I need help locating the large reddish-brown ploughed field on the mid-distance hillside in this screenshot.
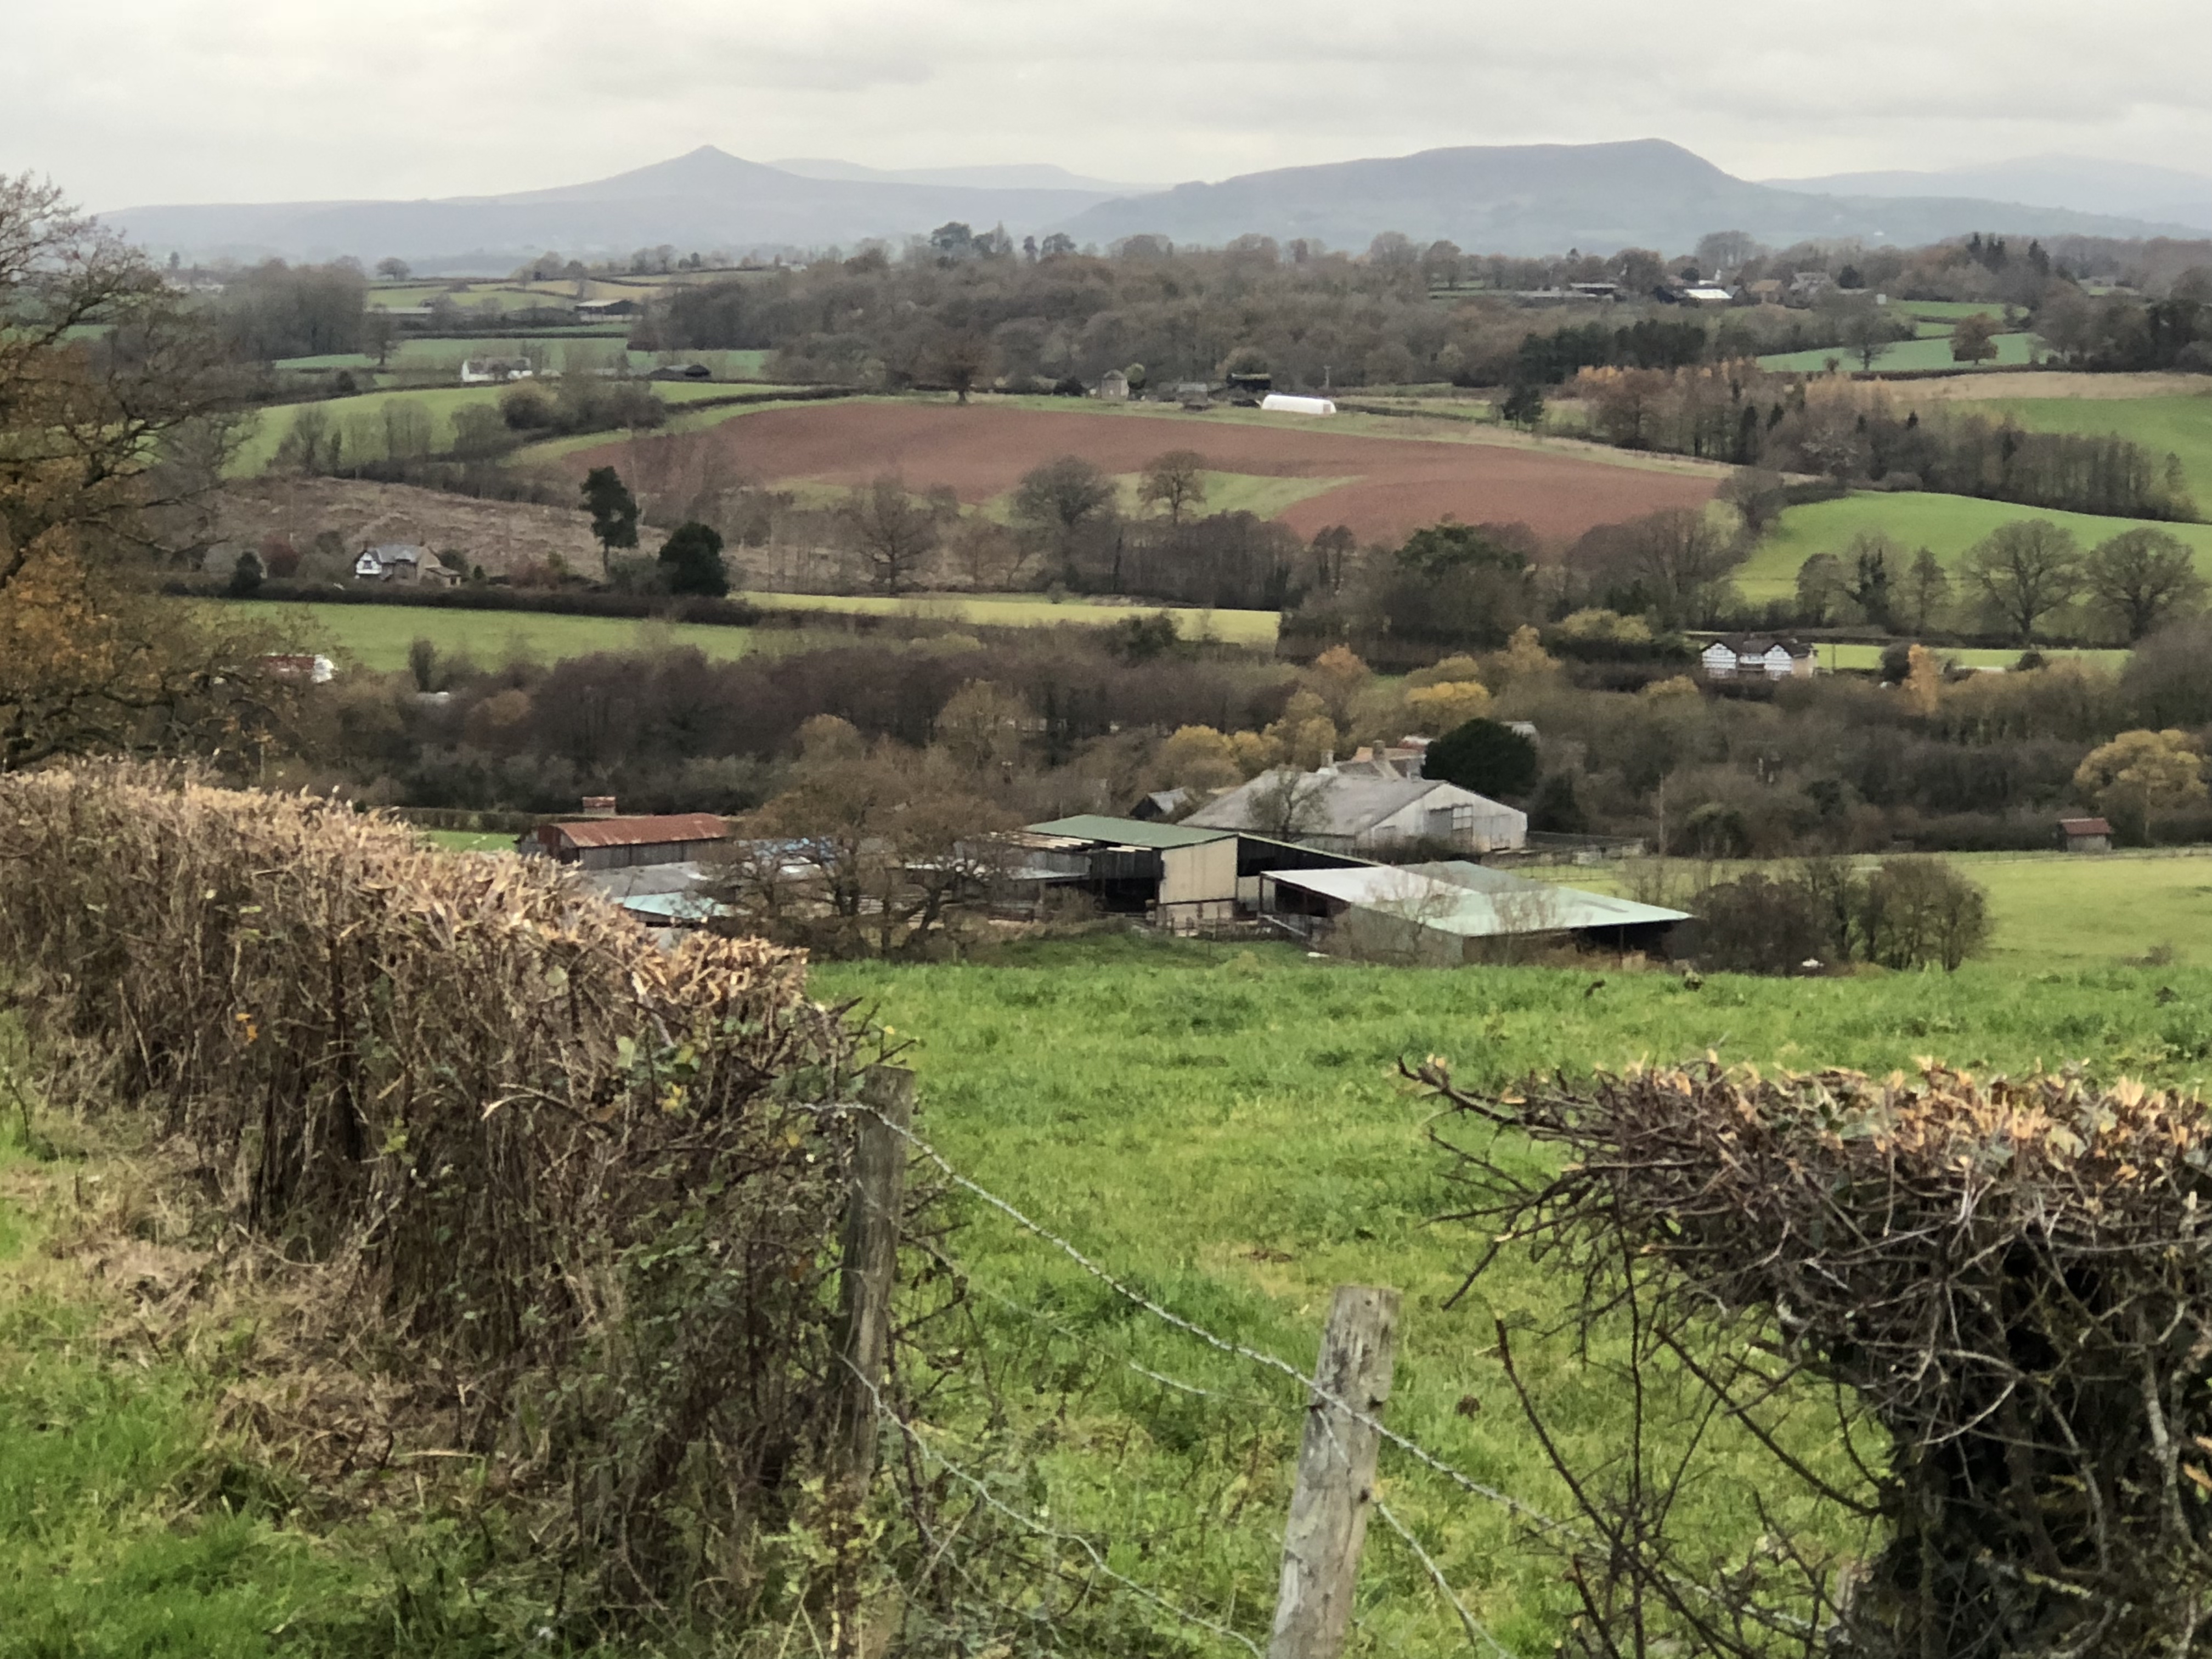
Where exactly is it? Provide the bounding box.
[568,403,1719,540]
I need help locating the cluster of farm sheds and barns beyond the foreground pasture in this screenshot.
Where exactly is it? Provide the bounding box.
[517,770,1690,967]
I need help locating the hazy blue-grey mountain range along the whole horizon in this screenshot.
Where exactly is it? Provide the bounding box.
[101,139,2212,272]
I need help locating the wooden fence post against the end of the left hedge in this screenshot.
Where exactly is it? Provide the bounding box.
[830,1066,913,1657]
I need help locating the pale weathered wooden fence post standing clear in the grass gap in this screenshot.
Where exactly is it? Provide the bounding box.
[1267,1285,1398,1659]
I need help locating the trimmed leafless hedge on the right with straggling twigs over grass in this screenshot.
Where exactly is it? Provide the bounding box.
[1420,1059,2212,1659]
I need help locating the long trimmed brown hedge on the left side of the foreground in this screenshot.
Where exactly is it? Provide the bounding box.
[0,768,854,1606]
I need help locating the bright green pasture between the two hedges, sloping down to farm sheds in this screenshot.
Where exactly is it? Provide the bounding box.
[816,942,2212,1659]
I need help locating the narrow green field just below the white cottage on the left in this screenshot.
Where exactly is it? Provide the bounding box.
[204,600,761,673]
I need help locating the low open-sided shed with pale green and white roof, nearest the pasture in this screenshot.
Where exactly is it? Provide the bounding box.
[1259,860,1690,967]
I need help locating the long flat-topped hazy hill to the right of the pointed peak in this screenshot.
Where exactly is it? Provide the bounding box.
[1068,139,2185,255]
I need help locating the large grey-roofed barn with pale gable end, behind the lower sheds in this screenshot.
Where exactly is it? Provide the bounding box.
[1183,768,1528,854]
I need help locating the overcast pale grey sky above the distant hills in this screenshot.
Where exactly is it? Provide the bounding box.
[0,0,2212,208]
